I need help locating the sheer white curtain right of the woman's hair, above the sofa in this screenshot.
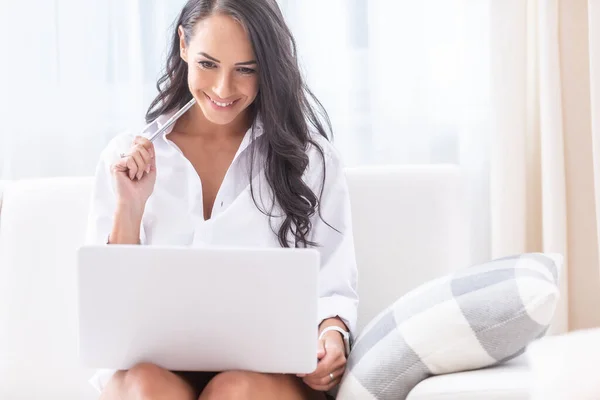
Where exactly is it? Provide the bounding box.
[280,0,492,263]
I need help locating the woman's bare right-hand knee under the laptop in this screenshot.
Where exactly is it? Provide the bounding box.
[198,371,325,400]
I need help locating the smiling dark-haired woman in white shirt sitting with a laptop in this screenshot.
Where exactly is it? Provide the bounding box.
[88,0,358,400]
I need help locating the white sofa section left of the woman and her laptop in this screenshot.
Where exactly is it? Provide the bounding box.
[0,177,97,400]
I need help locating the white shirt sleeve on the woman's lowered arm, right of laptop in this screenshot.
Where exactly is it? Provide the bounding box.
[311,138,358,338]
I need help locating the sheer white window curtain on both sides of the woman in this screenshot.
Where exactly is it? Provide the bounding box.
[0,0,491,268]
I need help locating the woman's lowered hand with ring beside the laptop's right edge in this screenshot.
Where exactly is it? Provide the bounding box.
[298,331,346,392]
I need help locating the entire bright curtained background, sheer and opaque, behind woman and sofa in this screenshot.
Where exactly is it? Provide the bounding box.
[0,0,600,328]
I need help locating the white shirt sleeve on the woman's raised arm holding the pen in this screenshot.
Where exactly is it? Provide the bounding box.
[85,134,146,245]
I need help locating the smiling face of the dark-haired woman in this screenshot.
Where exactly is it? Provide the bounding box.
[179,14,258,125]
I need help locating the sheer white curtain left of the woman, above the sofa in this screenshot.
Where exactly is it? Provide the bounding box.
[0,0,184,179]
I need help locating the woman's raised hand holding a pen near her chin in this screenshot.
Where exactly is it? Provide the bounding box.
[111,136,156,211]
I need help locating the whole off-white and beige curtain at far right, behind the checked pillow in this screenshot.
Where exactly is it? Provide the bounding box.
[490,0,600,332]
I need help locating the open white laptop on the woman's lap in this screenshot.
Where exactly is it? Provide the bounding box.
[77,245,319,374]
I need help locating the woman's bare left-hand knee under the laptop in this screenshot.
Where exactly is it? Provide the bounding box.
[100,364,196,400]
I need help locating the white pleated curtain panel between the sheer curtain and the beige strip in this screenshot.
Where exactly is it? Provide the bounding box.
[490,0,568,332]
